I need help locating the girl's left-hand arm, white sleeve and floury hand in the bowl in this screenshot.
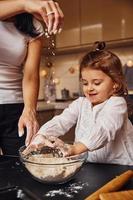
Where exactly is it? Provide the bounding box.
[24,98,82,154]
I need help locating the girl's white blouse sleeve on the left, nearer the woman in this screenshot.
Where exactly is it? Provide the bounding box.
[39,98,80,137]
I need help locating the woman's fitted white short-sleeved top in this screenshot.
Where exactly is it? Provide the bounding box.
[0,19,44,104]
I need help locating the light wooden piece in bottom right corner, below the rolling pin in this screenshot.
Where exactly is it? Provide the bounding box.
[100,190,133,200]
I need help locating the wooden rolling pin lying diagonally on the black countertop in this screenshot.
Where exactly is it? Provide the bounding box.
[85,170,133,200]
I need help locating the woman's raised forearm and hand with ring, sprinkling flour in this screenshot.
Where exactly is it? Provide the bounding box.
[0,0,64,34]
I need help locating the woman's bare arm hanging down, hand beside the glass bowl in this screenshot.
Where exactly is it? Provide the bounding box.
[18,37,43,145]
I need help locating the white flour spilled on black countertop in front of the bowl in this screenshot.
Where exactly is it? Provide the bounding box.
[44,182,88,198]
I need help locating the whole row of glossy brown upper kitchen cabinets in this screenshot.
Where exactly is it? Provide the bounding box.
[56,0,133,50]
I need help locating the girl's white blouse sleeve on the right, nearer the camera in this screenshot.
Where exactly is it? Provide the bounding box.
[80,98,127,151]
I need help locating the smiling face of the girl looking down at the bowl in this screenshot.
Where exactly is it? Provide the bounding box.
[81,68,116,105]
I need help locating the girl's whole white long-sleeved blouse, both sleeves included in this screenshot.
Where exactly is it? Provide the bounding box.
[39,97,133,165]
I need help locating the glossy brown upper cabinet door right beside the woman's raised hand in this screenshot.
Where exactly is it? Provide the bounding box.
[56,0,80,48]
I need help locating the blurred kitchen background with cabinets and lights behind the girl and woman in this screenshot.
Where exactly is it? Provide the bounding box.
[38,0,133,140]
